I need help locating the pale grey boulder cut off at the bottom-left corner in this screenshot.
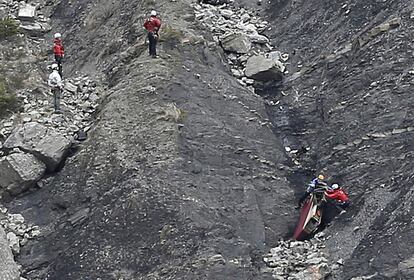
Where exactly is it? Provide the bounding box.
[0,225,20,280]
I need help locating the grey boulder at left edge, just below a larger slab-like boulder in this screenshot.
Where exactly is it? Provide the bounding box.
[0,153,46,195]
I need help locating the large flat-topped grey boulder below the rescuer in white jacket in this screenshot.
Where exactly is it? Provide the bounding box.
[3,122,71,172]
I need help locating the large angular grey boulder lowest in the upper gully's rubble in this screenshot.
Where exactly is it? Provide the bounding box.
[245,55,285,82]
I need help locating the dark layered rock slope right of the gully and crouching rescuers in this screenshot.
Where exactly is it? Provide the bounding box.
[249,1,414,279]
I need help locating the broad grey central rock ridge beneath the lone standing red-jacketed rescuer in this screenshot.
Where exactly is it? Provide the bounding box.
[10,1,293,279]
